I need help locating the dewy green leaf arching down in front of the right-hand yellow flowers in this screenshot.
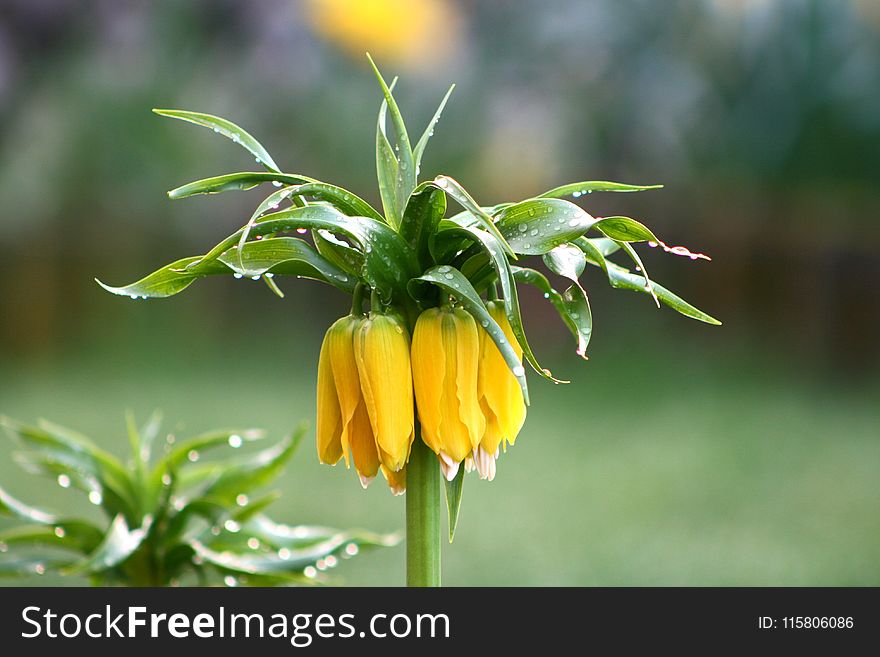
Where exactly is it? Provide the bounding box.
[408,265,529,404]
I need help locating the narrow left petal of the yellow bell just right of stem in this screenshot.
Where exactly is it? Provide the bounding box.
[411,308,445,454]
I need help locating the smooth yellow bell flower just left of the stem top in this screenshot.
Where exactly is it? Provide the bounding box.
[354,313,414,472]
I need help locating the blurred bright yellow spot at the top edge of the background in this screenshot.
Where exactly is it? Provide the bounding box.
[306,0,461,69]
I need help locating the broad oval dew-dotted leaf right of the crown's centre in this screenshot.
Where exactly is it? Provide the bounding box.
[496,198,596,255]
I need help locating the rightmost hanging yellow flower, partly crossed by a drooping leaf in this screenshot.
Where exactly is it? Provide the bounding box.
[473,301,526,481]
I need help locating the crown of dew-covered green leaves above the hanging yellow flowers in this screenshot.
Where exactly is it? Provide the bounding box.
[96,58,720,532]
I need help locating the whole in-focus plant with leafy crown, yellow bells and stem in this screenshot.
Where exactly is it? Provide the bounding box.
[102,55,719,586]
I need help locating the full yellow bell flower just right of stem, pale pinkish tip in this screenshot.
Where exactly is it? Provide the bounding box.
[412,307,486,481]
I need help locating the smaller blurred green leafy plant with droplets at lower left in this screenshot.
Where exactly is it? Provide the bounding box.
[0,413,400,586]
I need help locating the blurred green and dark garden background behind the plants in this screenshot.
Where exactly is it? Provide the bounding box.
[0,0,880,585]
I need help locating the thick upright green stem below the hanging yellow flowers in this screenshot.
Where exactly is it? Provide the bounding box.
[406,428,440,586]
